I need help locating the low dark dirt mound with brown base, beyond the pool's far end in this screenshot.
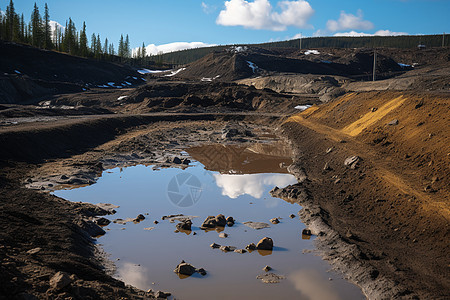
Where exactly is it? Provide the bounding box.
[116,82,301,113]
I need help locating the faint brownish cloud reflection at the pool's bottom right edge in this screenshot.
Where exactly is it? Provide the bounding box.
[288,270,341,300]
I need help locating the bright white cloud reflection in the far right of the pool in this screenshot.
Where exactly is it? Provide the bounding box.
[213,174,297,199]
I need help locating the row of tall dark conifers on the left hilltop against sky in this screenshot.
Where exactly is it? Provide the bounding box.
[0,0,138,61]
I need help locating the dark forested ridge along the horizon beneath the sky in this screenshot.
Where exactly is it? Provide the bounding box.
[161,34,450,64]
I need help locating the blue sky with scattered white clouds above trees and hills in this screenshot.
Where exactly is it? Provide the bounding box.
[0,0,450,53]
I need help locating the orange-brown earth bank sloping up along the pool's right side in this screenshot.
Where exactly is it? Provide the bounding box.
[273,93,450,299]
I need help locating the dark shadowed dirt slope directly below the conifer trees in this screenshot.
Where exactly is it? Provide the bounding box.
[0,41,143,103]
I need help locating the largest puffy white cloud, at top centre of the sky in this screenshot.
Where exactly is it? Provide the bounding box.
[216,0,314,31]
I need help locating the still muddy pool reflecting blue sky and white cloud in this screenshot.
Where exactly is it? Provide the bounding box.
[55,144,364,300]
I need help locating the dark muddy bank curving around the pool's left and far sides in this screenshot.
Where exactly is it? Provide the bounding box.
[0,114,278,299]
